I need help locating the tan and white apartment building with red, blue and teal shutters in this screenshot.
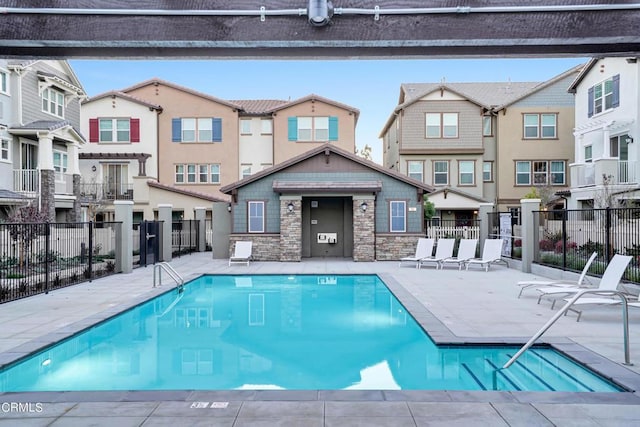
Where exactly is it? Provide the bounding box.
[82,78,359,219]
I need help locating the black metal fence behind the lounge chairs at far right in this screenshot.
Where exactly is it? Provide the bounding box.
[534,208,640,283]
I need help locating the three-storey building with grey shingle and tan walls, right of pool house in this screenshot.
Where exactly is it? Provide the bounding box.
[380,67,579,224]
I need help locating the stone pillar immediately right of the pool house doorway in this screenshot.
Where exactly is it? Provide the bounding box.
[353,195,376,261]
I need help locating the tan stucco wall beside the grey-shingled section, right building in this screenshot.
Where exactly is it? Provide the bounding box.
[495,106,574,210]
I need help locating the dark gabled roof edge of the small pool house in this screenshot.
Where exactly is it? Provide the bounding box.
[220,143,434,194]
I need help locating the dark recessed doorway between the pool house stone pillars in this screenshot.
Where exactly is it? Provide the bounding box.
[302,197,353,258]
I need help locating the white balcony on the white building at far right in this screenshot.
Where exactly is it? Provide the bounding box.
[570,158,638,187]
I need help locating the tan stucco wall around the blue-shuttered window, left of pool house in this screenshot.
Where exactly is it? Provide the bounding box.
[128,84,239,202]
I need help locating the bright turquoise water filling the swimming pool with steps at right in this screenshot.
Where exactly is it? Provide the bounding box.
[0,275,619,391]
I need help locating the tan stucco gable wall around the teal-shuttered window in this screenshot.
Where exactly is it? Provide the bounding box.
[273,100,356,164]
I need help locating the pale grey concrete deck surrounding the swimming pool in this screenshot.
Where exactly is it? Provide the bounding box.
[0,252,640,427]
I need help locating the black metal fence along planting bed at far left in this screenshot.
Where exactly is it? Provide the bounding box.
[0,222,122,303]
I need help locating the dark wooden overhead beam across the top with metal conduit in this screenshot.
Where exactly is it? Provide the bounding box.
[0,0,640,59]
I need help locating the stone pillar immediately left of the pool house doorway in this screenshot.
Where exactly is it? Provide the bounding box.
[280,196,302,261]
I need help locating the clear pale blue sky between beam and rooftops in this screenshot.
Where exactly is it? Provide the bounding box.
[69,58,588,163]
